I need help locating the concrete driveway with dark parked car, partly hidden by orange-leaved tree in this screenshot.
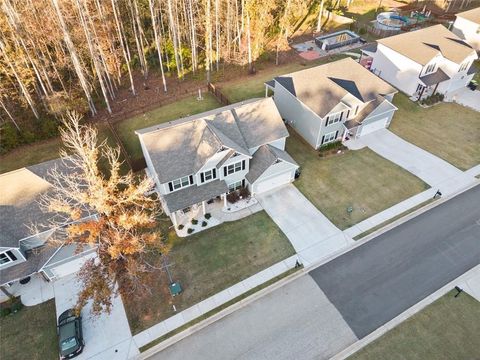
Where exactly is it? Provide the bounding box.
[53,275,139,360]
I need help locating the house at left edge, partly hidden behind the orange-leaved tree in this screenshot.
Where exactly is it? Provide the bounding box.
[0,159,92,286]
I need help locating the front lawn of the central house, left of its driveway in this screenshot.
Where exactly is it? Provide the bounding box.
[124,211,295,334]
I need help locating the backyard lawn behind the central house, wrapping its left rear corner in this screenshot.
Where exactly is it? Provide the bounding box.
[115,93,221,159]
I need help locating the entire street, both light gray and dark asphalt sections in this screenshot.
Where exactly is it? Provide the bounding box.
[148,186,480,360]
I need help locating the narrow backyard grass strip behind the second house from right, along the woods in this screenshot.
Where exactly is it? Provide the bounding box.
[220,54,346,103]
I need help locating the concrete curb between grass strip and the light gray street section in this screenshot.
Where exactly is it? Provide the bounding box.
[136,269,305,360]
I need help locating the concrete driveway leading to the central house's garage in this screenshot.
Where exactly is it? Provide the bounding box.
[255,184,353,265]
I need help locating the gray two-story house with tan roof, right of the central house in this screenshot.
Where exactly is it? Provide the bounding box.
[265,58,397,149]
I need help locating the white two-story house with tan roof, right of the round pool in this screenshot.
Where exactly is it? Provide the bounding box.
[362,25,477,99]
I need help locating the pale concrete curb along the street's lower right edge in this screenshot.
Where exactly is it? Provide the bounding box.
[330,265,480,360]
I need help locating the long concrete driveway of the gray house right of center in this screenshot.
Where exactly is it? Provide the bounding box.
[356,129,474,195]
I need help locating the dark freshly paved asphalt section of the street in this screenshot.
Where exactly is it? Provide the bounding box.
[310,186,480,338]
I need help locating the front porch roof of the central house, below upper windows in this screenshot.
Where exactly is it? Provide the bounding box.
[163,180,228,212]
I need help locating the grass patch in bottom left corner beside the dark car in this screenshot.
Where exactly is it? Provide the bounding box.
[0,300,58,360]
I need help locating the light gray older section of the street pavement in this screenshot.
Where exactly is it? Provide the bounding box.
[150,275,357,360]
